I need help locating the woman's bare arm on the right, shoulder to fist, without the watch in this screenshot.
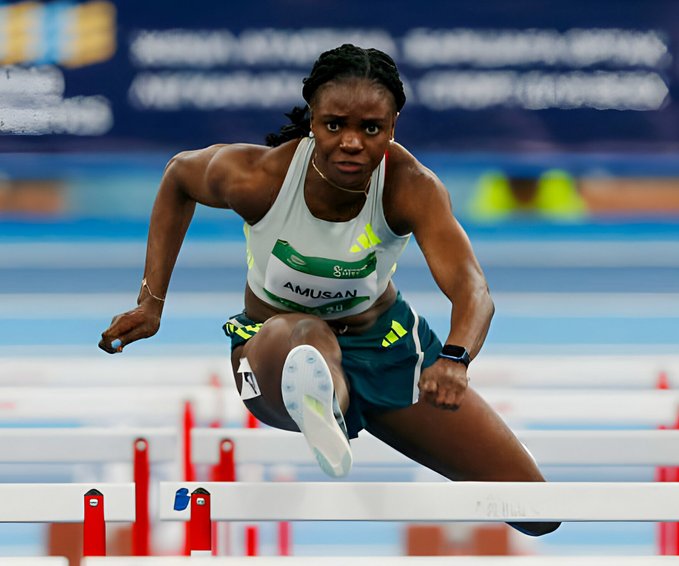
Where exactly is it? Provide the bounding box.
[392,151,495,409]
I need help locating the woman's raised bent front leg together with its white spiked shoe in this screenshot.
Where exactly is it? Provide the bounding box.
[232,314,352,477]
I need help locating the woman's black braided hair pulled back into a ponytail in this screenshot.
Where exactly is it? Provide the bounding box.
[266,43,406,147]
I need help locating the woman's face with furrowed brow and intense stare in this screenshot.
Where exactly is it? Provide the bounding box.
[311,78,396,193]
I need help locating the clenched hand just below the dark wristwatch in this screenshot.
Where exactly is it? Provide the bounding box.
[418,358,469,411]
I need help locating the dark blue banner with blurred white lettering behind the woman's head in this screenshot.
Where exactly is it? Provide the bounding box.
[0,0,679,152]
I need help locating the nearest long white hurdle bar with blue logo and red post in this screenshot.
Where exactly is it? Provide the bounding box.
[159,482,679,554]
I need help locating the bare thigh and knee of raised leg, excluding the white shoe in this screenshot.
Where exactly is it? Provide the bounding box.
[231,314,349,430]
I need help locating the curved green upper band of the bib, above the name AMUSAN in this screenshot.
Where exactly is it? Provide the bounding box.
[271,240,377,279]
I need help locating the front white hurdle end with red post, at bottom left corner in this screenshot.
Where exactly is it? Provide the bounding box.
[0,483,135,556]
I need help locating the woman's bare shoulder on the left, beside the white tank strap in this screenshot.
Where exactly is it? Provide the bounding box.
[171,142,297,222]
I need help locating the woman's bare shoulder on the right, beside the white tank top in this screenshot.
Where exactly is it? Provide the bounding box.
[384,142,451,234]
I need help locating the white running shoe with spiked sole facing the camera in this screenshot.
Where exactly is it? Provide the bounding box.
[281,344,353,478]
